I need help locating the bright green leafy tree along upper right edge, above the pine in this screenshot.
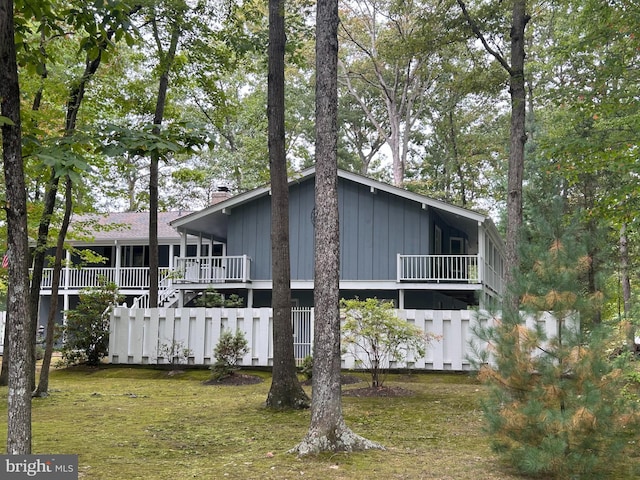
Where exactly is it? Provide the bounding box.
[537,1,640,328]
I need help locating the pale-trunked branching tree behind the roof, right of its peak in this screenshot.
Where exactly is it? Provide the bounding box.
[339,0,448,186]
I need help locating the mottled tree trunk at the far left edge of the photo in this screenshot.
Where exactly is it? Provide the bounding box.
[0,0,34,455]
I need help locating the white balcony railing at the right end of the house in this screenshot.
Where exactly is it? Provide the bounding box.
[398,254,481,283]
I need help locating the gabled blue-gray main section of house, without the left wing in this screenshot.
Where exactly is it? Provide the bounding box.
[165,168,504,310]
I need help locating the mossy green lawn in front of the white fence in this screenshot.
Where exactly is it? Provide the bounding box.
[0,367,640,480]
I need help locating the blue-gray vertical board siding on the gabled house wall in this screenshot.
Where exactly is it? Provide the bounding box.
[227,177,466,281]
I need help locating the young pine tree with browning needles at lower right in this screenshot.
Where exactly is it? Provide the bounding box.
[476,199,636,478]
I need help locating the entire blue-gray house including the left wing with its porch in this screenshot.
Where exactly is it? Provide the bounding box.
[40,168,504,330]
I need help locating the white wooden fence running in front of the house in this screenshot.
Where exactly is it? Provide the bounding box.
[108,307,572,371]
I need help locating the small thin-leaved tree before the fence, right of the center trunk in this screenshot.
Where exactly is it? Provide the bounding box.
[340,298,436,387]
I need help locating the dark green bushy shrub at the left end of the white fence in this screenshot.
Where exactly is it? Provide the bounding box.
[62,278,124,365]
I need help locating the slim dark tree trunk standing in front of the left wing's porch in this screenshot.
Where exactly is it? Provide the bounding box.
[149,20,182,308]
